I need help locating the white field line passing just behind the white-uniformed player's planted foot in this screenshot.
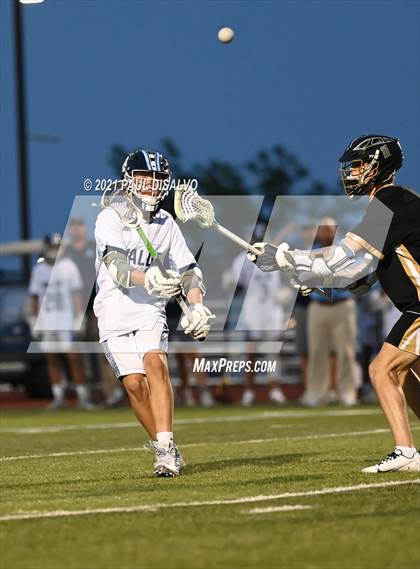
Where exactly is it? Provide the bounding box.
[0,427,420,462]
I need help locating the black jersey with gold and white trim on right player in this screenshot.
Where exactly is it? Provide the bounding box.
[347,185,420,314]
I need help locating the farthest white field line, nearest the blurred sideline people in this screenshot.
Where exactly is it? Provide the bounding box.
[0,409,381,435]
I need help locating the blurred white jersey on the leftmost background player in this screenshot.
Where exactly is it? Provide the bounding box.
[29,257,83,331]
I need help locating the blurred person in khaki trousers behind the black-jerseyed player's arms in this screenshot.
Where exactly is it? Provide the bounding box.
[301,218,357,407]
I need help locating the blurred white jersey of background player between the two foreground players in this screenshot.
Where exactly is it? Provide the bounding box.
[231,252,284,331]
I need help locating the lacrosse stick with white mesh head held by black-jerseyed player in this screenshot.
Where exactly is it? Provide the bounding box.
[174,184,329,296]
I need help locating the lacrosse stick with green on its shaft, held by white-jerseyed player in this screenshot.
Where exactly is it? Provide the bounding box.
[101,180,194,322]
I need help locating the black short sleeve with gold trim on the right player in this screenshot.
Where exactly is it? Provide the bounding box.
[346,191,407,260]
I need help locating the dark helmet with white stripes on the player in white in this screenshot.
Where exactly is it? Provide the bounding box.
[122,150,171,215]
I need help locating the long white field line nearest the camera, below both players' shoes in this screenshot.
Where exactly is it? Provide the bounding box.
[0,478,420,522]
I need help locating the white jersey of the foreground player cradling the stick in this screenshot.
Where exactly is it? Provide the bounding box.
[93,209,196,342]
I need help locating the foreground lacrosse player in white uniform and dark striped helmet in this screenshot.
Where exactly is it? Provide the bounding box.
[94,150,214,477]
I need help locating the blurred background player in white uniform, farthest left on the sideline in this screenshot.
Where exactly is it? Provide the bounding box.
[29,233,94,410]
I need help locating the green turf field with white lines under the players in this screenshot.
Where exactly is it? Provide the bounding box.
[0,407,420,569]
